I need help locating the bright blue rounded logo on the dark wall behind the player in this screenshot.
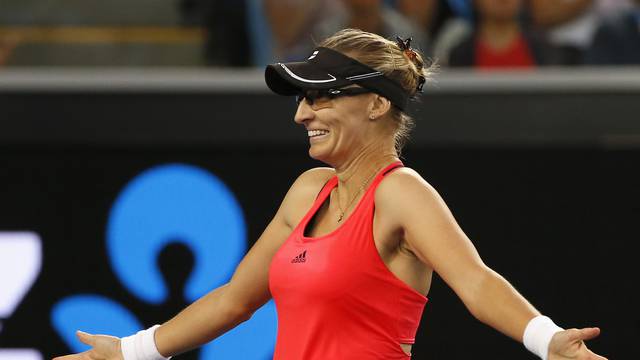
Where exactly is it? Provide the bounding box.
[51,164,277,360]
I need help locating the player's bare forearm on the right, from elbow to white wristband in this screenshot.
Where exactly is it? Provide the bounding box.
[465,269,540,342]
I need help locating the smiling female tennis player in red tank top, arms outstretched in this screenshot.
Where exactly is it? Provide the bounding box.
[56,29,605,360]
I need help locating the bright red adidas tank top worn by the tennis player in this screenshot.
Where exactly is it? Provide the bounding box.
[269,161,427,360]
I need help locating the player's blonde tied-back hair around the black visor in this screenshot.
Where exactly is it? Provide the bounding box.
[318,29,434,155]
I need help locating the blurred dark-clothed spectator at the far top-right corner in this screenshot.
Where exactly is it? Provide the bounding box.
[586,0,640,65]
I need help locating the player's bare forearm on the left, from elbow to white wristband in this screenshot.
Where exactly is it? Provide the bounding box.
[155,284,251,356]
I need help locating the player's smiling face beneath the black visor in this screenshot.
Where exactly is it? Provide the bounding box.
[294,88,384,167]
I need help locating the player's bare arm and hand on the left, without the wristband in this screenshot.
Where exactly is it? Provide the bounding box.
[54,168,333,360]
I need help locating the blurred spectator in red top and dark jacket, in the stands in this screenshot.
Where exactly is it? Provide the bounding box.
[449,0,554,68]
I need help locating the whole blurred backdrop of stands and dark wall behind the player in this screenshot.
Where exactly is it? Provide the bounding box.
[0,0,640,360]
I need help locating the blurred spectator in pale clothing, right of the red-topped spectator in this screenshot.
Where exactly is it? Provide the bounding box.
[529,0,630,65]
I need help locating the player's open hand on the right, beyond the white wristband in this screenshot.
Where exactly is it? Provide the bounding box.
[548,328,607,360]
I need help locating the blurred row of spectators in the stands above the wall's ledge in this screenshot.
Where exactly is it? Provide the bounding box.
[196,0,640,69]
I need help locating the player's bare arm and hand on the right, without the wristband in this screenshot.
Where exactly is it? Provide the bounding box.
[376,168,604,360]
